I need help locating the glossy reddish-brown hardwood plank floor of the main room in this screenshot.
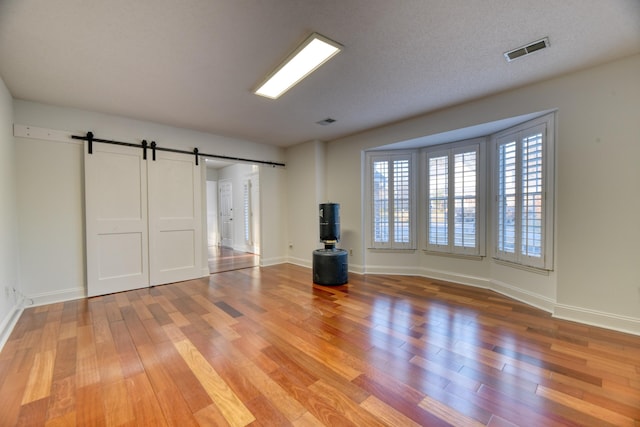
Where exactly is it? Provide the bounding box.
[0,264,640,427]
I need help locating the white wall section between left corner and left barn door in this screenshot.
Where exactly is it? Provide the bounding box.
[16,138,86,303]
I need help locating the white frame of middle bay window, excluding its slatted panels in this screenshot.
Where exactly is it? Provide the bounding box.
[421,137,487,256]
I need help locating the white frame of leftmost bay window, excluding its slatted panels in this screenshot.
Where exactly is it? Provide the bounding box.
[366,150,417,250]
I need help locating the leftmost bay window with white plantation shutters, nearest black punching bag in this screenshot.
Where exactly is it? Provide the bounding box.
[368,152,415,249]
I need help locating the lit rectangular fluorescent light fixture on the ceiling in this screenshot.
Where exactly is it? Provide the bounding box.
[254,33,342,99]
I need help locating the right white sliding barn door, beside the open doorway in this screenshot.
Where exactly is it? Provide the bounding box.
[148,151,203,286]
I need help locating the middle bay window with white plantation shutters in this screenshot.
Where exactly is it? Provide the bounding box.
[426,140,484,255]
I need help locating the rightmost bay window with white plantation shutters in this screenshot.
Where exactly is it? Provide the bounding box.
[494,115,554,270]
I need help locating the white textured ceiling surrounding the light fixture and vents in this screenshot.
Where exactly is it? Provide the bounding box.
[0,0,640,147]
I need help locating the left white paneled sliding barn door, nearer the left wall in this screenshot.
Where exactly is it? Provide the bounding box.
[84,144,149,296]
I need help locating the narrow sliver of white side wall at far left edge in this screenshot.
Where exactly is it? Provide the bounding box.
[0,75,21,348]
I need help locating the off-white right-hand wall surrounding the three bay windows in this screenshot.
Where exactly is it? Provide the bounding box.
[320,55,640,334]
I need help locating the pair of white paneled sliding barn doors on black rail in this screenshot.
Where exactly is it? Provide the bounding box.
[84,143,203,297]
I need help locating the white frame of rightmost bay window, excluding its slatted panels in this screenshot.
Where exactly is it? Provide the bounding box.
[491,113,556,271]
